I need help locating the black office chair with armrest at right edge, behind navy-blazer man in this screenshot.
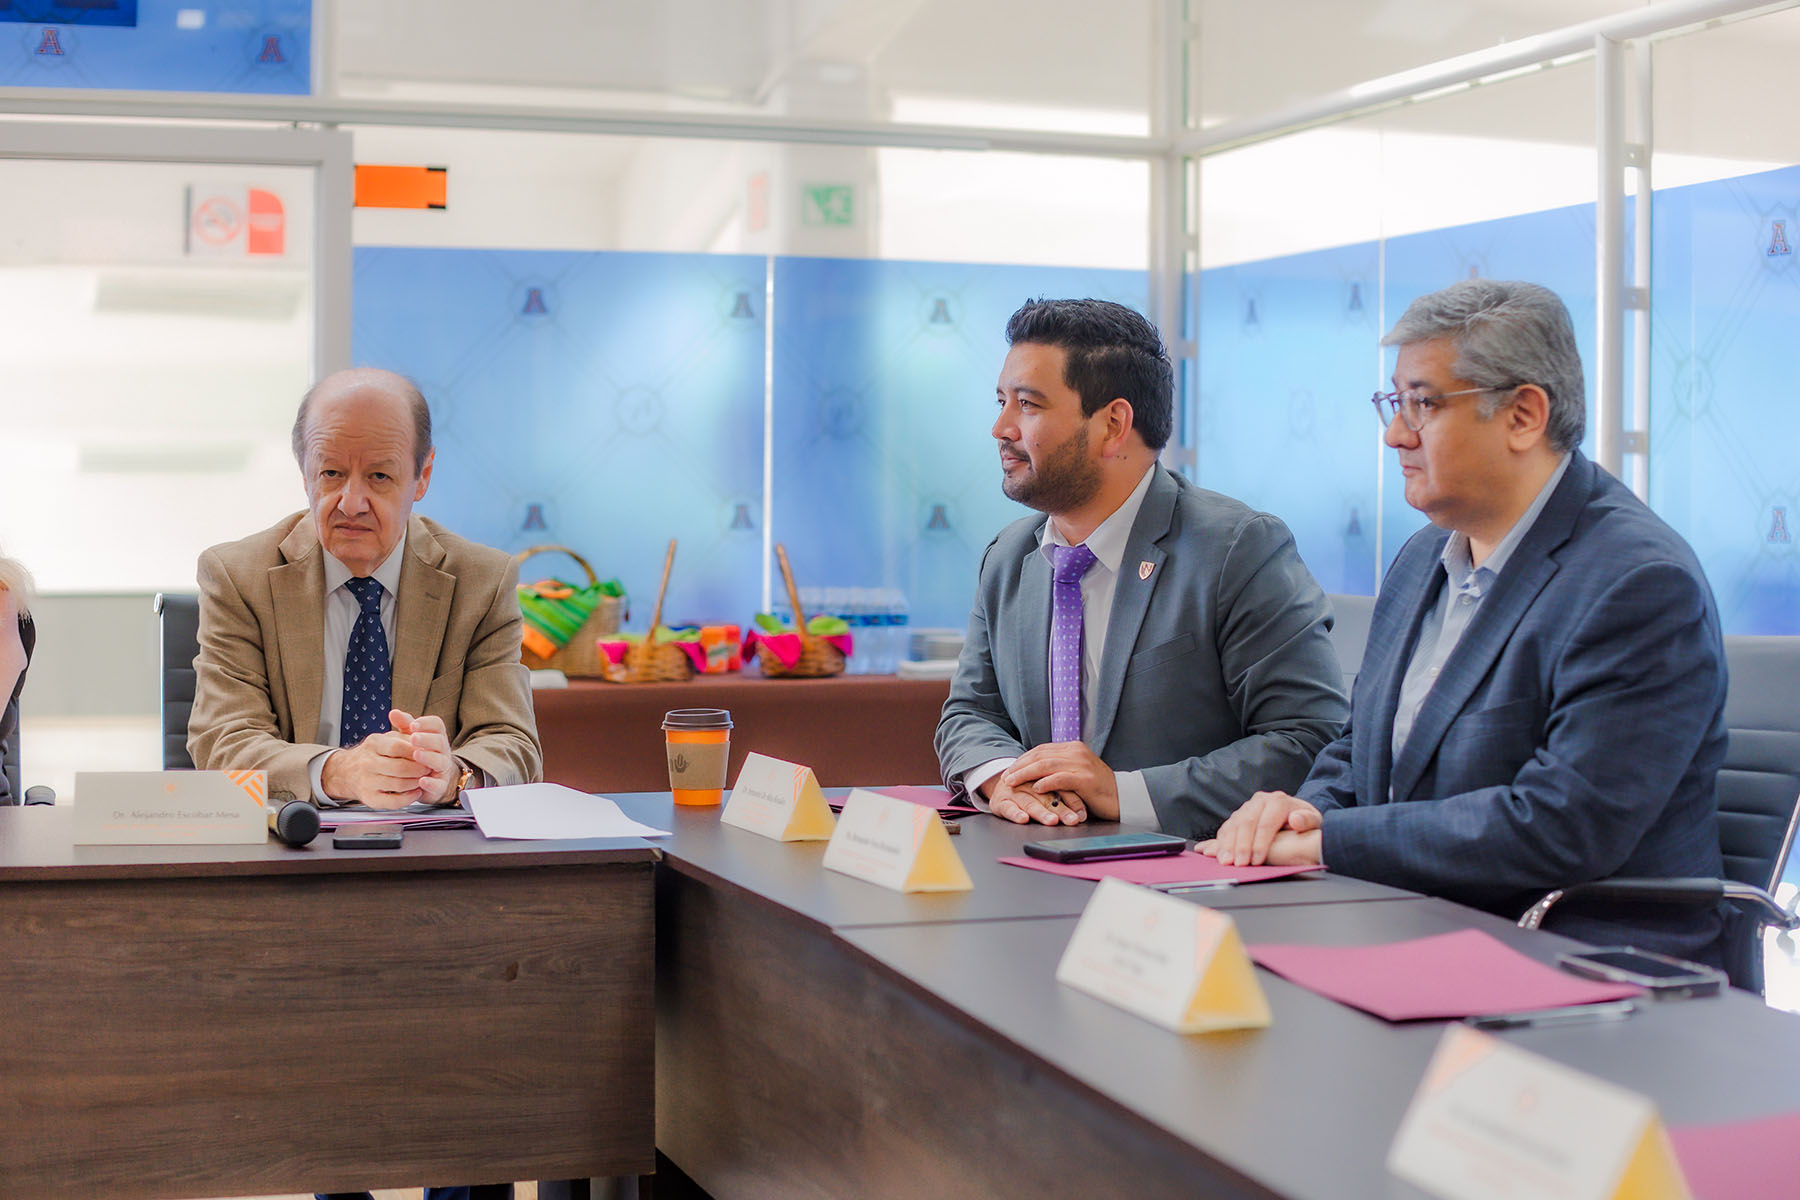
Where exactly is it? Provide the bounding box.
[1519,637,1800,993]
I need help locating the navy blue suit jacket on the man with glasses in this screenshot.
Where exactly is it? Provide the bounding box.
[1298,452,1726,963]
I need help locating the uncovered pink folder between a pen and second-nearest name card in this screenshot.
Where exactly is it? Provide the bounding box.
[1249,928,1643,1020]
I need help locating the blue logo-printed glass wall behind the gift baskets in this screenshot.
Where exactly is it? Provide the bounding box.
[355,246,1147,626]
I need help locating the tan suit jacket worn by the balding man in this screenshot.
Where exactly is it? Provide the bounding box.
[187,513,544,799]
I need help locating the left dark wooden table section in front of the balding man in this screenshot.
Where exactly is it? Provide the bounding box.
[0,806,657,1196]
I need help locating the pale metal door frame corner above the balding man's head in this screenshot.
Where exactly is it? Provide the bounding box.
[0,120,355,378]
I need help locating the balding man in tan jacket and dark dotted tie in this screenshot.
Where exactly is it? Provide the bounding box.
[187,369,542,827]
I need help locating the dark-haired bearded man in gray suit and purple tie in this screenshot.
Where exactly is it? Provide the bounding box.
[936,300,1346,837]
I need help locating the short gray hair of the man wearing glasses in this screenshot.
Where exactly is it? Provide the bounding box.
[1381,279,1588,450]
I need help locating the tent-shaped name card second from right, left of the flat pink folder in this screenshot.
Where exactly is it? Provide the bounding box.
[1057,878,1269,1033]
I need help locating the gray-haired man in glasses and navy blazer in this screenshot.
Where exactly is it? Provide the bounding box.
[1201,279,1726,963]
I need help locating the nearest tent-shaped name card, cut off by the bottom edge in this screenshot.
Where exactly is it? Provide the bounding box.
[1388,1025,1690,1200]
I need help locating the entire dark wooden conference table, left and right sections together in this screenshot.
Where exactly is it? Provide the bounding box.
[0,793,1800,1200]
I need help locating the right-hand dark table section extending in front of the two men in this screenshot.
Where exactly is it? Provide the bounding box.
[621,795,1800,1200]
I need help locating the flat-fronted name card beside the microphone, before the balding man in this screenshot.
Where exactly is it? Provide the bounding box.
[76,770,268,846]
